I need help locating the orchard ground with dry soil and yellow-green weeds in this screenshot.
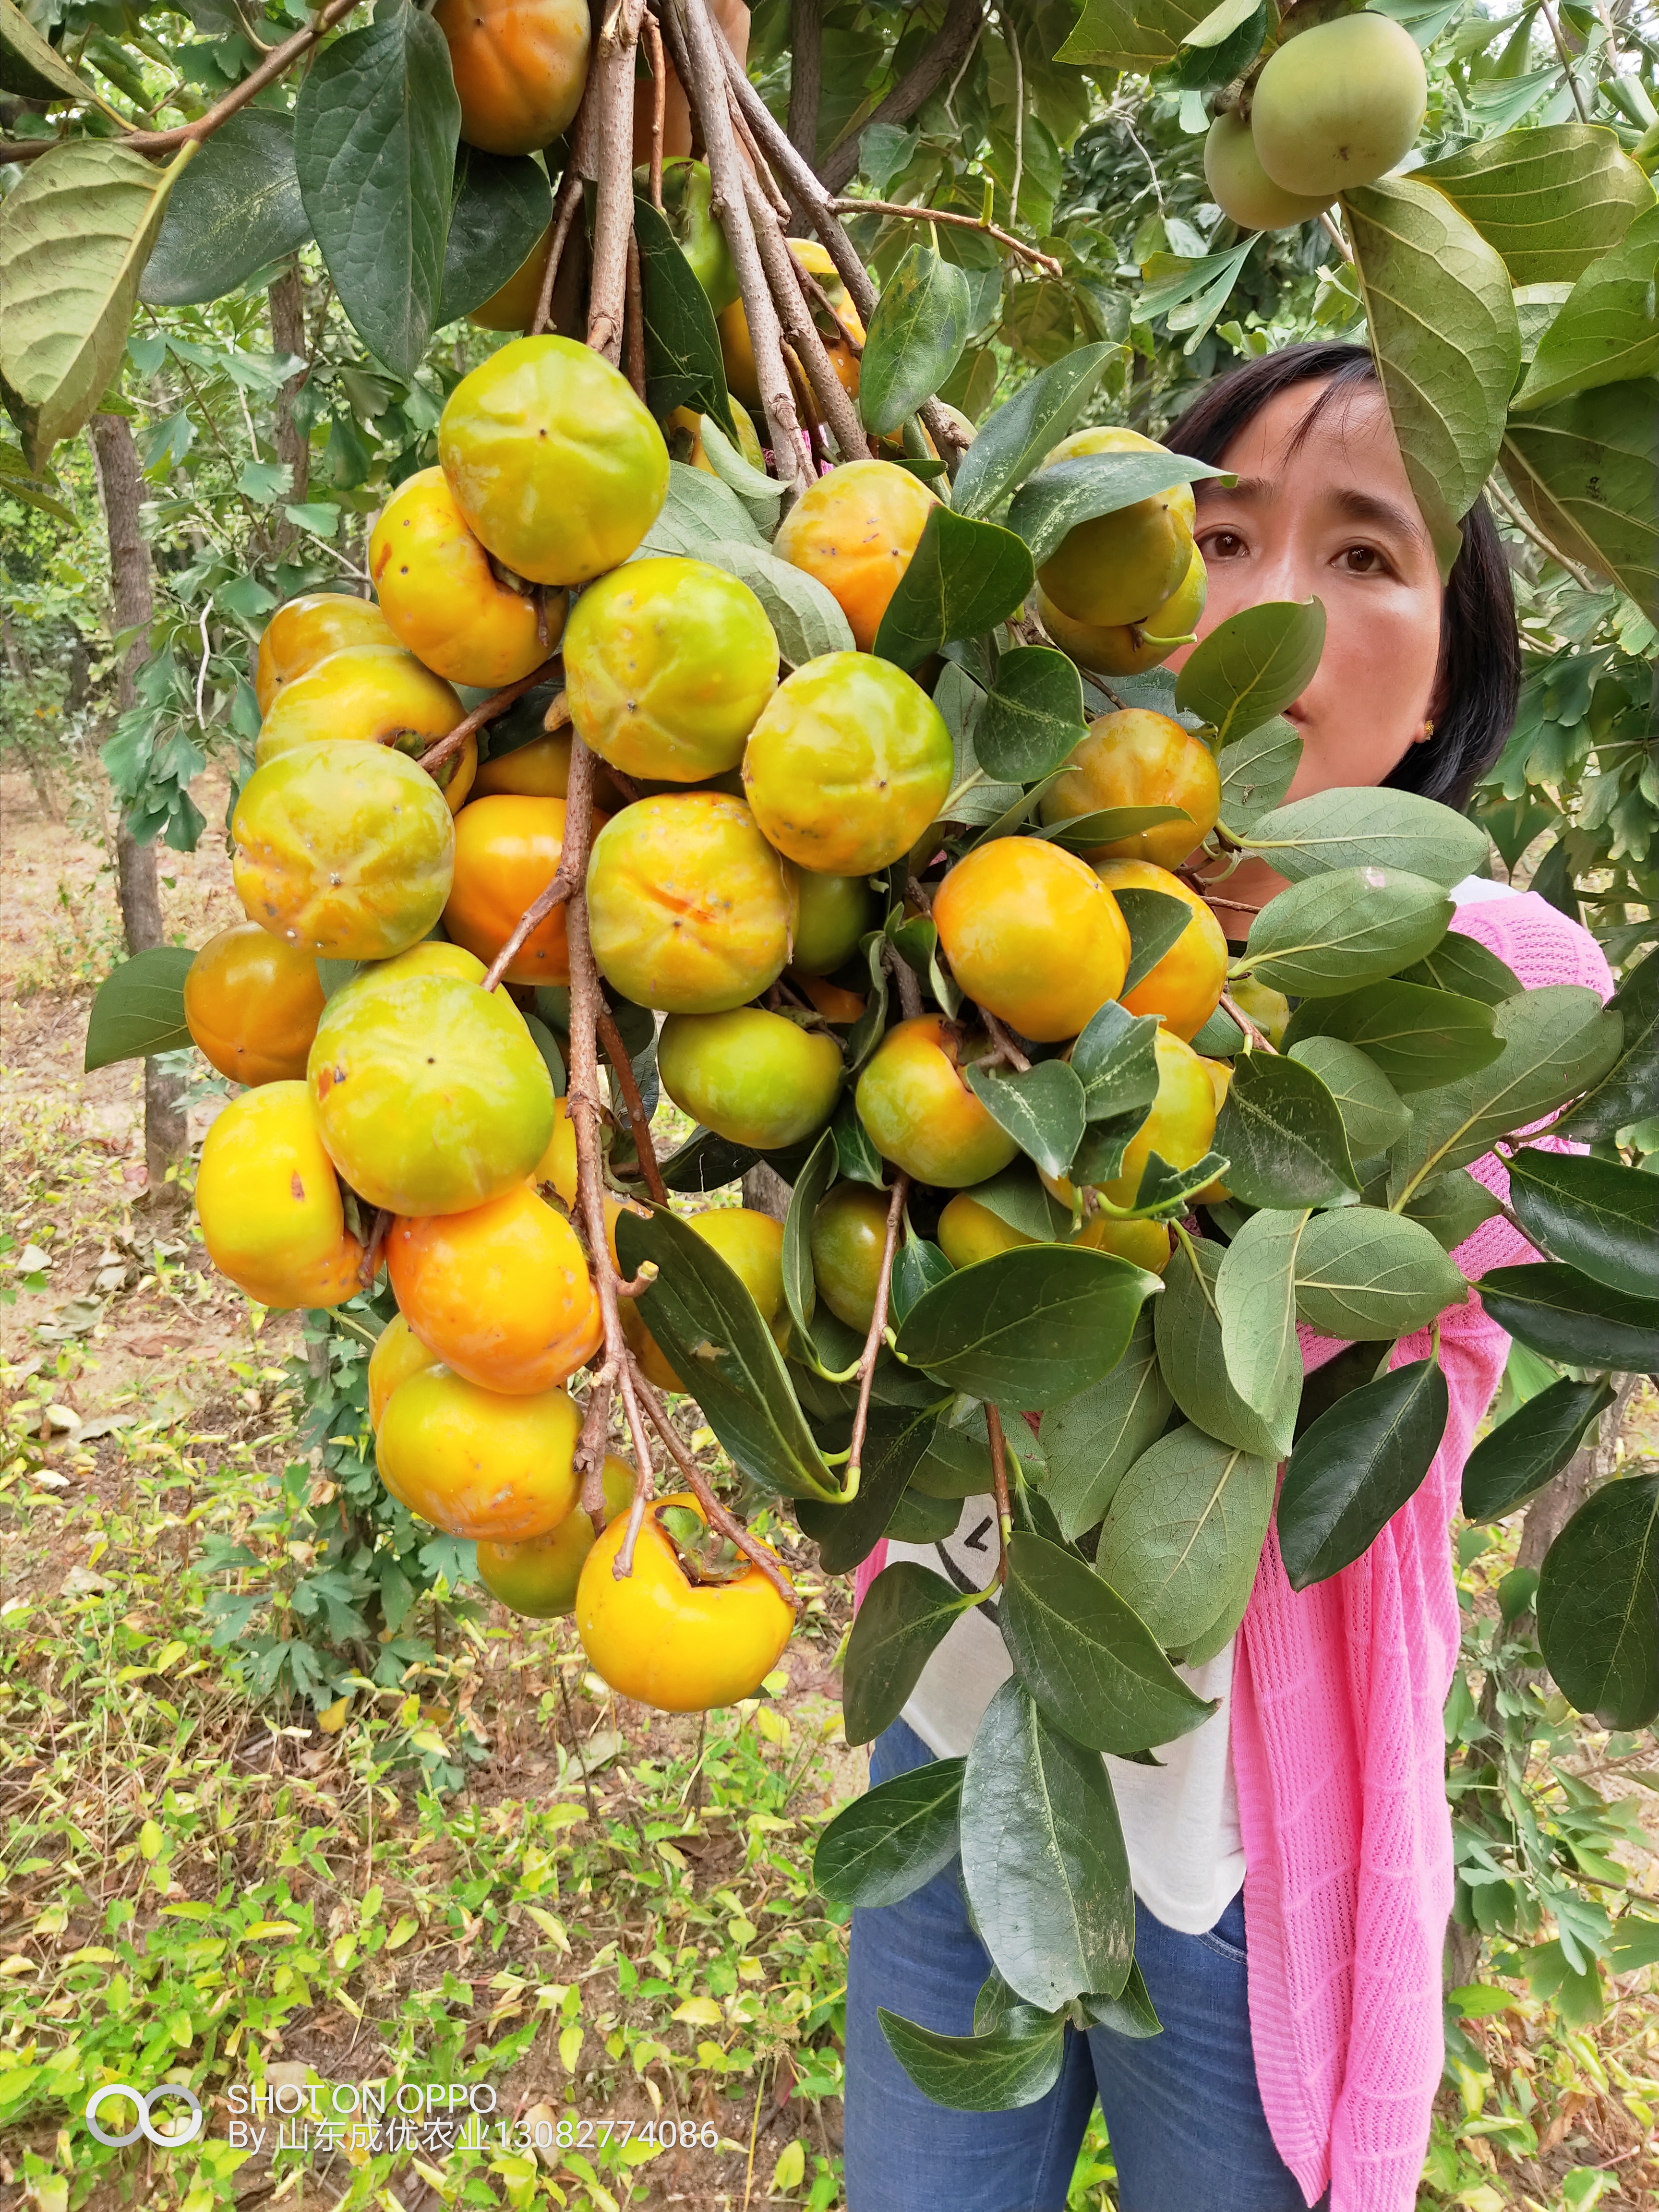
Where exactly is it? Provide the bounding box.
[0,747,1659,2212]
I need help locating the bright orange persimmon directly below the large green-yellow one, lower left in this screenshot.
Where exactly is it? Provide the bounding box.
[387,1181,604,1398]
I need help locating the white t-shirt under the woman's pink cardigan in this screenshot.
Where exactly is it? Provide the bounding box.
[887,876,1515,1936]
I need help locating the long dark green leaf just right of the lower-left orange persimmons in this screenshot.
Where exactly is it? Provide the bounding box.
[617,1208,838,1504]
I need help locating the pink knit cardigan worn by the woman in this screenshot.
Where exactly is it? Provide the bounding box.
[854,891,1612,2212]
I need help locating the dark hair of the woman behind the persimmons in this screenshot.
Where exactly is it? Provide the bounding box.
[1164,343,1520,807]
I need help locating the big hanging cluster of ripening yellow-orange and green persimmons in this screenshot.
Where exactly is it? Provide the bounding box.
[186,323,1227,1707]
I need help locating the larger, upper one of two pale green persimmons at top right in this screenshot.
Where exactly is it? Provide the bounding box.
[1250,11,1429,199]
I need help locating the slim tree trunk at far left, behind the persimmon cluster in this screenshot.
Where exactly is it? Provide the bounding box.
[93,414,188,1203]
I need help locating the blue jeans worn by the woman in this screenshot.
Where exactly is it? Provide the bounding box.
[845,1721,1305,2212]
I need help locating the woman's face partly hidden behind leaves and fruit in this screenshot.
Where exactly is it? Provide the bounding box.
[1170,383,1440,798]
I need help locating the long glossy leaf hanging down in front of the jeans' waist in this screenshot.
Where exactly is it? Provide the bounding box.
[960,1681,1135,2011]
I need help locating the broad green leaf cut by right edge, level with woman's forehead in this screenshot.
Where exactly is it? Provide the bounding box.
[1504,378,1659,617]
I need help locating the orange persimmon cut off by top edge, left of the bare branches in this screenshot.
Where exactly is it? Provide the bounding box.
[432,0,590,153]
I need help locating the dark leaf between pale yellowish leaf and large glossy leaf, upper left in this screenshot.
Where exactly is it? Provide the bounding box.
[139,108,312,308]
